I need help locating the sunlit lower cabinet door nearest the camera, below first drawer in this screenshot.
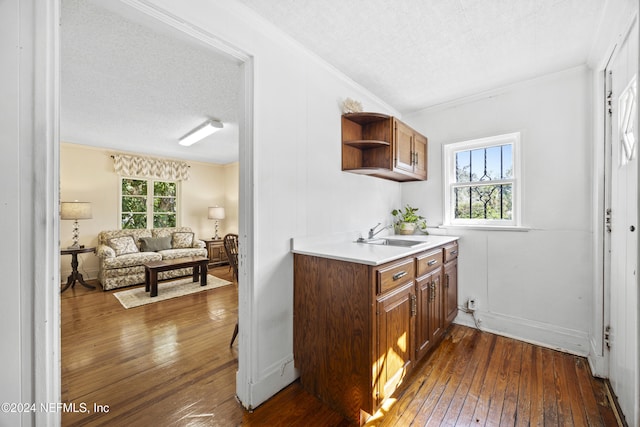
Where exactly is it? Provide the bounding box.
[374,281,417,404]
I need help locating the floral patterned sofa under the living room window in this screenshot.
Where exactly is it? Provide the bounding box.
[96,227,207,291]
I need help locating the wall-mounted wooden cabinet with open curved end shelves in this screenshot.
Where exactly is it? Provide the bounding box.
[342,113,428,181]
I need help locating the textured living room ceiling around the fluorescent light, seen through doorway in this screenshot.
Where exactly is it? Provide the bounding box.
[60,0,241,164]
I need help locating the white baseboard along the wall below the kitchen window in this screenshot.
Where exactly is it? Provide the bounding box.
[454,311,591,357]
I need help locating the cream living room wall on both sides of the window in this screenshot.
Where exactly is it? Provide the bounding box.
[60,143,238,282]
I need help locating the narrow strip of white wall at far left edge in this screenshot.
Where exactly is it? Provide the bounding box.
[0,0,33,425]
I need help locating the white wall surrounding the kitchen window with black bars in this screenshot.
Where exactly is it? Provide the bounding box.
[402,67,594,355]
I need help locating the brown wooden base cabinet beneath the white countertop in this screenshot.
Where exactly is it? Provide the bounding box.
[293,241,457,424]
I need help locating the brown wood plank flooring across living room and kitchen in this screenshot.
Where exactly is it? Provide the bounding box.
[61,272,617,427]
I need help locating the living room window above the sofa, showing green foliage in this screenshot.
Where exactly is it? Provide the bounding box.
[120,178,179,229]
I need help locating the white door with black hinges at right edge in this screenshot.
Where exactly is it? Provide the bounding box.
[609,15,640,426]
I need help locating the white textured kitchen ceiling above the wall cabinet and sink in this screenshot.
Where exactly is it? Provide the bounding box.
[238,0,605,112]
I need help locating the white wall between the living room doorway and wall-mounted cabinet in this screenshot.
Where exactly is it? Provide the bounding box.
[133,0,400,407]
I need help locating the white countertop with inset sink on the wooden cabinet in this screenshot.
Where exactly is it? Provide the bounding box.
[292,234,459,265]
